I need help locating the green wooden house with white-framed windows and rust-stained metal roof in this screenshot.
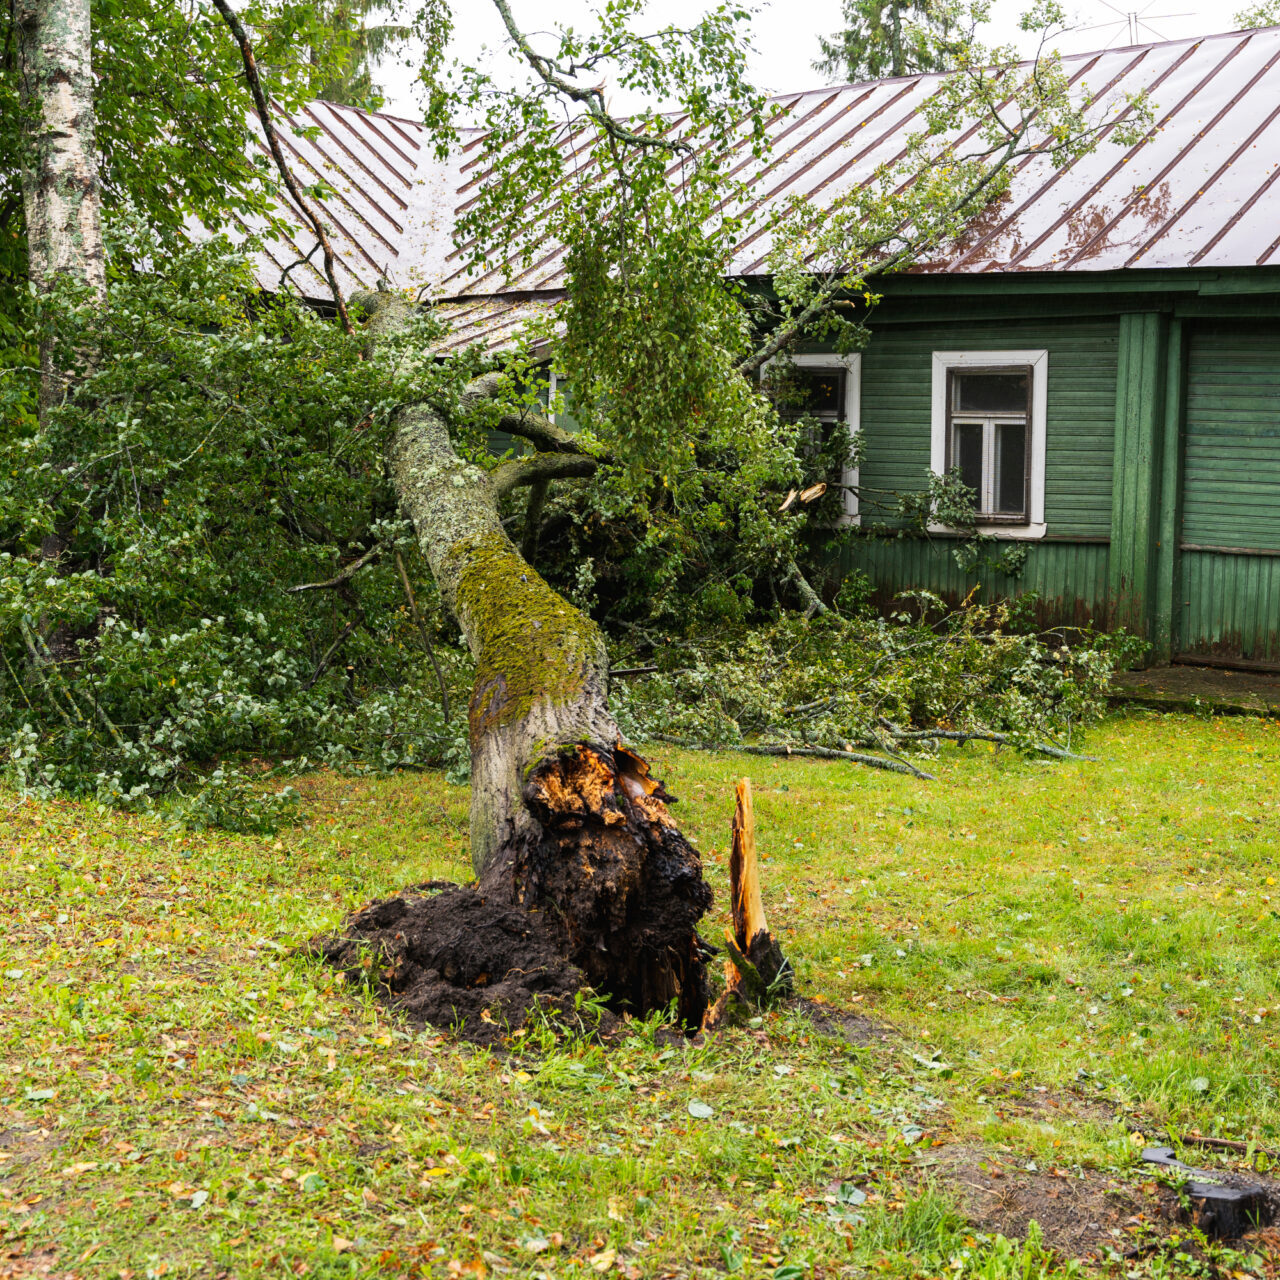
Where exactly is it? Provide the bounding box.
[247,28,1280,668]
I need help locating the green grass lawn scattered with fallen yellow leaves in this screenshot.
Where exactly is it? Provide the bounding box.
[0,713,1280,1280]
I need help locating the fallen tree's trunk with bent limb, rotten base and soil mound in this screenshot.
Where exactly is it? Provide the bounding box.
[325,294,712,1027]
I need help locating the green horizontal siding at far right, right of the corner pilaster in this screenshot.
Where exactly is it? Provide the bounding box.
[1181,325,1280,550]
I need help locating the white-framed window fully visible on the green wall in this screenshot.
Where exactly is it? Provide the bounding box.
[931,351,1048,538]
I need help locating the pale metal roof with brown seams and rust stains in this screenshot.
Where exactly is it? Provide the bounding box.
[241,27,1280,343]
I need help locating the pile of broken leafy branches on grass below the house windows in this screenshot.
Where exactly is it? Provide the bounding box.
[614,593,1134,780]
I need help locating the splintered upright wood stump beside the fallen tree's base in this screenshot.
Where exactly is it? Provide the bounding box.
[704,778,794,1028]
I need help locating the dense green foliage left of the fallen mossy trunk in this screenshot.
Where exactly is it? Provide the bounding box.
[0,227,470,832]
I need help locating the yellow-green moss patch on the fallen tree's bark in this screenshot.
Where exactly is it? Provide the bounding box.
[449,534,605,741]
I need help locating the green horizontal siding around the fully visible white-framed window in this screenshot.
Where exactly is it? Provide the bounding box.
[860,319,1117,538]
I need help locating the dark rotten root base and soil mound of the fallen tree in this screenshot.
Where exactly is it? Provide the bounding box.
[315,744,712,1042]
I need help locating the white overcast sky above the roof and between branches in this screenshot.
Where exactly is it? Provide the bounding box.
[371,0,1245,118]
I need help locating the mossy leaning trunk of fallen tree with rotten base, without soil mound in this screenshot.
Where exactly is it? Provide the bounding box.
[362,294,710,1027]
